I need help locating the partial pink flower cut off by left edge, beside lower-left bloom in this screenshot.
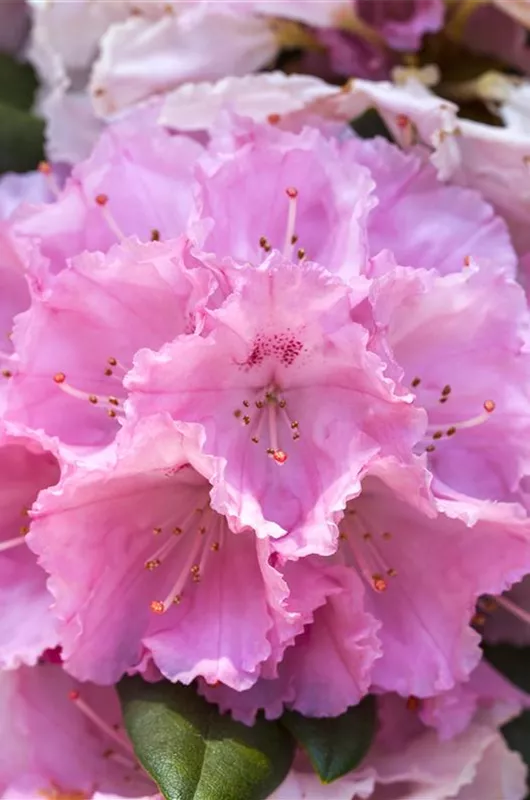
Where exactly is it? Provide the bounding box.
[0,424,59,669]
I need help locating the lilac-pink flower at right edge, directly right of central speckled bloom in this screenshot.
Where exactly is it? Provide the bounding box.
[366,260,530,501]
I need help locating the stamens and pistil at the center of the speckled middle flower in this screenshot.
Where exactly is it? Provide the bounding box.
[234,387,300,466]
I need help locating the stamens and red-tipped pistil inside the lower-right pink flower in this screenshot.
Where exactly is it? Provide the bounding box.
[339,505,397,592]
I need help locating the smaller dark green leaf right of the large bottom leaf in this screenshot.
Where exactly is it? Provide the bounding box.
[281,696,376,783]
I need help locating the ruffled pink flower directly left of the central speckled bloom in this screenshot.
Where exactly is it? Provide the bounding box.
[6,238,211,445]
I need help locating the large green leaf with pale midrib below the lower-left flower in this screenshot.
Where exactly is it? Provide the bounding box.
[118,677,295,800]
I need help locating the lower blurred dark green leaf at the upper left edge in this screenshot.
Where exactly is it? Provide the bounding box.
[0,103,44,173]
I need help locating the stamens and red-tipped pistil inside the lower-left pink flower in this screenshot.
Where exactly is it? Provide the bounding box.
[144,504,225,614]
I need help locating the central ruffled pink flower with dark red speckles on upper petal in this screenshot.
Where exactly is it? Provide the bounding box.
[126,255,423,556]
